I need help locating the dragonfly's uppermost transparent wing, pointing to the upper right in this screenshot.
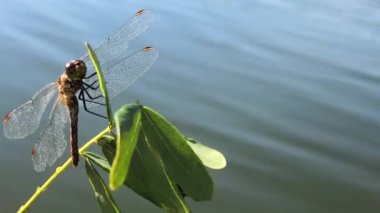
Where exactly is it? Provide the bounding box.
[80,10,153,66]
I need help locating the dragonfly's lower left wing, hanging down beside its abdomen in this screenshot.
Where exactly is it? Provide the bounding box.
[32,98,69,172]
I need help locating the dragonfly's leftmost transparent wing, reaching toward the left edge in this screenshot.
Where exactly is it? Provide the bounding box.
[3,82,58,139]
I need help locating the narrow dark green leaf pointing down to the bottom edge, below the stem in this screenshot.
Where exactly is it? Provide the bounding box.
[85,159,120,212]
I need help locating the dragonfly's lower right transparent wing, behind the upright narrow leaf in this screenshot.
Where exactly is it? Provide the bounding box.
[81,47,159,107]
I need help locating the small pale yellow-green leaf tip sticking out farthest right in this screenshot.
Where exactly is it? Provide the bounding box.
[187,138,227,169]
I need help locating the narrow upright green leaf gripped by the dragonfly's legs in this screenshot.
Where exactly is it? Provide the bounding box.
[84,42,113,127]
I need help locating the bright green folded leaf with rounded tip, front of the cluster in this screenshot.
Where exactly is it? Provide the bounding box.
[110,105,141,190]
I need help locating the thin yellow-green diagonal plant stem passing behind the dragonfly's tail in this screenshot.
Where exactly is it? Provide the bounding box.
[18,127,110,213]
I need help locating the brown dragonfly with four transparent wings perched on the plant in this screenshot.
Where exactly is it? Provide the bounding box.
[3,10,159,172]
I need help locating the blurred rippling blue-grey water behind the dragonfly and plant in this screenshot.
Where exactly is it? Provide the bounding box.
[0,0,380,213]
